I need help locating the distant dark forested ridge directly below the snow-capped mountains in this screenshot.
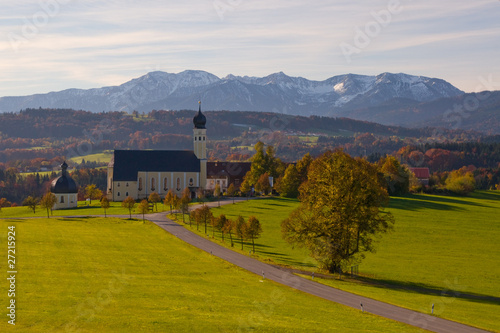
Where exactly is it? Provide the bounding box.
[0,109,478,141]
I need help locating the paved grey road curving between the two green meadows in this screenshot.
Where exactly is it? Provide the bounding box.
[148,198,486,333]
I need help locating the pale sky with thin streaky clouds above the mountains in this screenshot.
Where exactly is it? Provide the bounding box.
[0,0,500,96]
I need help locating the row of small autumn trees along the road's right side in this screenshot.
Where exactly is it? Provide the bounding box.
[189,205,262,252]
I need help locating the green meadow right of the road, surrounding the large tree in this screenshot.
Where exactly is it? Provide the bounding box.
[202,192,500,332]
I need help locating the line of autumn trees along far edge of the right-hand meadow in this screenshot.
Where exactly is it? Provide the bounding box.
[240,142,500,198]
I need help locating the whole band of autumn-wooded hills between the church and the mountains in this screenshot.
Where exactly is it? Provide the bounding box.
[0,109,500,172]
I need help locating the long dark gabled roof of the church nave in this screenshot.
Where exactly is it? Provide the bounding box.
[109,150,200,181]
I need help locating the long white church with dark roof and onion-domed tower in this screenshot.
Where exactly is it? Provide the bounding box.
[106,103,207,201]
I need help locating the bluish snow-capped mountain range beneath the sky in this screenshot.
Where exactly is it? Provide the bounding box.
[0,71,463,117]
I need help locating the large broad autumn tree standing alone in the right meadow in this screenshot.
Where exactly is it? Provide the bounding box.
[281,151,394,272]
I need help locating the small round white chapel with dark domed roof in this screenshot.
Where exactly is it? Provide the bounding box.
[50,162,78,209]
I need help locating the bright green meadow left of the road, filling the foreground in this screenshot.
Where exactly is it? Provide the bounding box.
[0,218,420,332]
